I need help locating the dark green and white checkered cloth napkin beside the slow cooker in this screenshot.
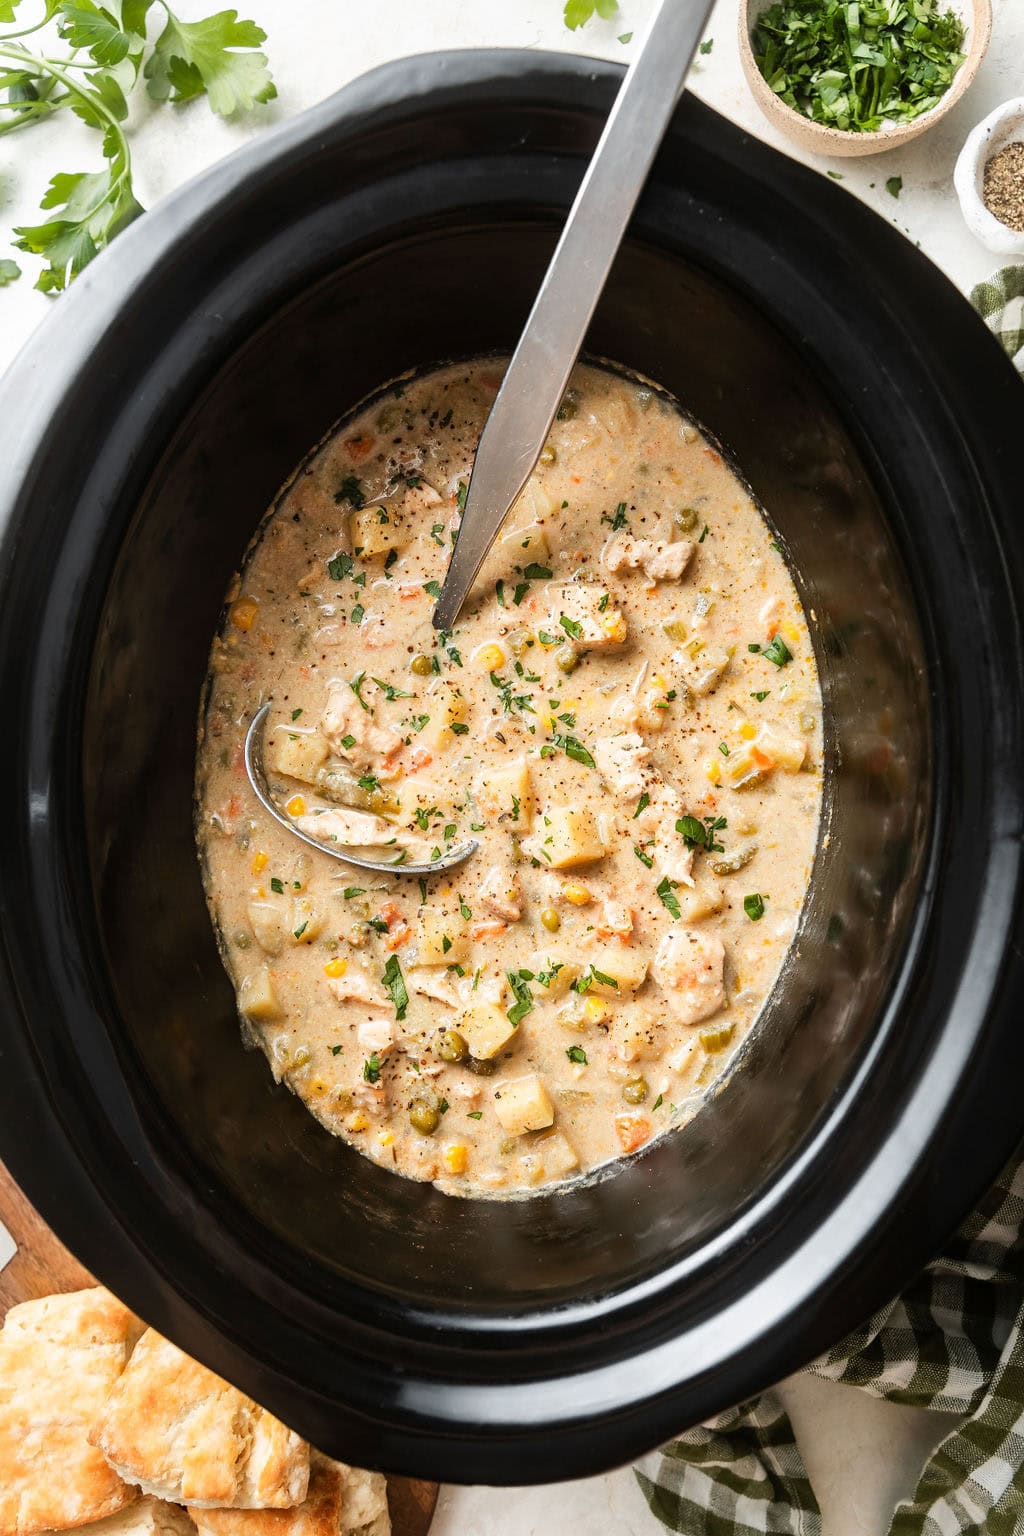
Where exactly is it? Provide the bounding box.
[636,267,1024,1536]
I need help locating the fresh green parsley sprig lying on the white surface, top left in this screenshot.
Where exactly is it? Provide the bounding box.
[0,0,276,293]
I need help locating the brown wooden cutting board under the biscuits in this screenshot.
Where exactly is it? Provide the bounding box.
[0,1163,439,1536]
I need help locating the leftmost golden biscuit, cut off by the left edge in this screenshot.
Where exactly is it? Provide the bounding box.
[0,1286,143,1536]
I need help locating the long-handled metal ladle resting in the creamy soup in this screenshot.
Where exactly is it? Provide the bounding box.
[246,0,712,876]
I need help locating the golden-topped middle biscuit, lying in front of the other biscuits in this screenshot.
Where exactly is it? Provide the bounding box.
[92,1329,309,1511]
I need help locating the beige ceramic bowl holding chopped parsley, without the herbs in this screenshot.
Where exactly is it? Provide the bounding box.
[740,0,992,157]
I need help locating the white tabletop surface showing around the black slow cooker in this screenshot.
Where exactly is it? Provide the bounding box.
[0,0,1024,1536]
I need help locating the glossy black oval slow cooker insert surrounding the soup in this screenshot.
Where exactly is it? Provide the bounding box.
[0,52,1024,1482]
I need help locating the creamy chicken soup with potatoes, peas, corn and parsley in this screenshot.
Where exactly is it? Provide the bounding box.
[198,359,821,1195]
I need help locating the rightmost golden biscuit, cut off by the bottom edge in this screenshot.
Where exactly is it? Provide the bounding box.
[189,1452,391,1536]
